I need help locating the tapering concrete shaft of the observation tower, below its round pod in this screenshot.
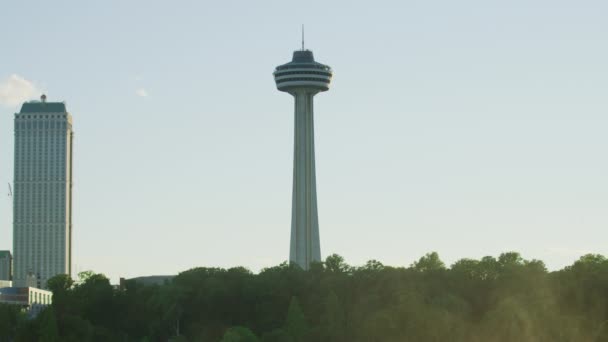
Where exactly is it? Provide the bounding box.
[289,90,321,269]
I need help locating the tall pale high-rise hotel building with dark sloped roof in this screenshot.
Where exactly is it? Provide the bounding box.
[13,95,73,288]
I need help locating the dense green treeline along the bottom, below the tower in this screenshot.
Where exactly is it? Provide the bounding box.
[0,253,608,342]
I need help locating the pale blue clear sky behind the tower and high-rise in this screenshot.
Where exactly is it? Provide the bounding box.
[0,0,608,282]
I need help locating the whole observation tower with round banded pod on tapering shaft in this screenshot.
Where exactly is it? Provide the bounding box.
[274,46,332,270]
